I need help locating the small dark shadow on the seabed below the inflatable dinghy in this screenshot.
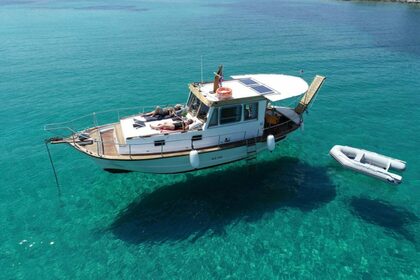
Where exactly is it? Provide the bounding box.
[349,197,420,243]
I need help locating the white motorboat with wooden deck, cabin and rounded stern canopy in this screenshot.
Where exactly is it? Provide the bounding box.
[45,67,325,173]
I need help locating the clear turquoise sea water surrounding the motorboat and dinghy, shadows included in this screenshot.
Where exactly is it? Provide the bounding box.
[0,0,420,279]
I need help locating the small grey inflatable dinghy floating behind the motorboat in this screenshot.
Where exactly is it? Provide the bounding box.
[330,145,406,184]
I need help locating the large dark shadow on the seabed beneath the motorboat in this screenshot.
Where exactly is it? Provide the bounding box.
[110,157,336,243]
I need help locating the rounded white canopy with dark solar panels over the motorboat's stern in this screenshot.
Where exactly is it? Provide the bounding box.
[232,74,309,102]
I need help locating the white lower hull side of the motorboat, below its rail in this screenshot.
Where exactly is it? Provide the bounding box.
[94,142,267,174]
